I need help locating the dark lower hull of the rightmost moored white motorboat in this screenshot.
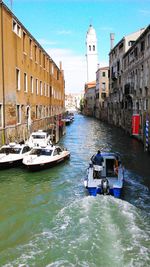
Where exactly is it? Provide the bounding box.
[25,154,70,172]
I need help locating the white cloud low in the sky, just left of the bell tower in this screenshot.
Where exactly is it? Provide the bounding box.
[46,48,86,93]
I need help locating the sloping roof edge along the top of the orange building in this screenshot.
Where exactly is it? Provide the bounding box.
[0,0,60,70]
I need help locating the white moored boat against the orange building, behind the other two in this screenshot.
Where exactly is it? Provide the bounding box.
[26,130,52,147]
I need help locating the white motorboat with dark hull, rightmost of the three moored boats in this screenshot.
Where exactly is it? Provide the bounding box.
[23,145,70,171]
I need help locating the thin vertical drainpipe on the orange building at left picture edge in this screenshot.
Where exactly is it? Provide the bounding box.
[1,2,5,144]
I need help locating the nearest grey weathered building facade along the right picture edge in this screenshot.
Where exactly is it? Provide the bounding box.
[123,26,150,144]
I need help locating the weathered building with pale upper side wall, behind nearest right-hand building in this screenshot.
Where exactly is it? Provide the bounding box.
[108,29,144,128]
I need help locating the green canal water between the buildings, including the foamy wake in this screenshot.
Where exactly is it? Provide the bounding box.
[0,115,150,267]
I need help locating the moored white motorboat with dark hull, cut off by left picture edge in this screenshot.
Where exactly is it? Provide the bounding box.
[0,142,31,169]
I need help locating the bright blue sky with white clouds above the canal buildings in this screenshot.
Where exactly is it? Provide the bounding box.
[4,0,150,93]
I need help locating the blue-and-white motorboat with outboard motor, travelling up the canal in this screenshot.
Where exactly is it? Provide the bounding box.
[84,152,124,198]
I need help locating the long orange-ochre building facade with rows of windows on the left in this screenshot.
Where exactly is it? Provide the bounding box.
[0,1,65,146]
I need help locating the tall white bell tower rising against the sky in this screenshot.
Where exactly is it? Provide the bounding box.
[86,24,98,82]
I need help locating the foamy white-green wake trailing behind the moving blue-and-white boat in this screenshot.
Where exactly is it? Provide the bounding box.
[4,196,150,267]
